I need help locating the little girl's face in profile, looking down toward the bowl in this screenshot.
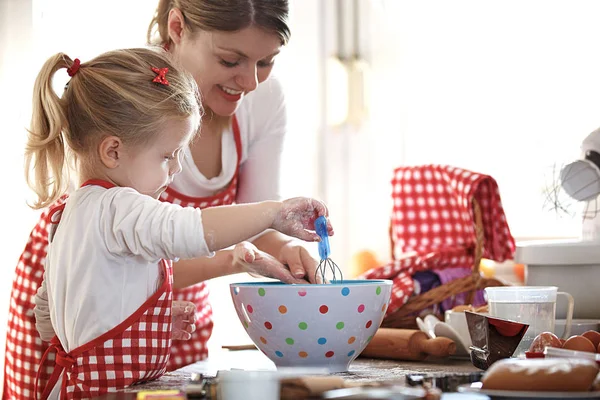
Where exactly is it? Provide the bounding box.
[118,116,198,199]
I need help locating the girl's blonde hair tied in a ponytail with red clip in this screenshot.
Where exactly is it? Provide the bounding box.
[25,48,201,208]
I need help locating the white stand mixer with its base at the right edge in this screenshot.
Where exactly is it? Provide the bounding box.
[515,128,600,319]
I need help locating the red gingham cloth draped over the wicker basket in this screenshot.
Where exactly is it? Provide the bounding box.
[363,165,515,315]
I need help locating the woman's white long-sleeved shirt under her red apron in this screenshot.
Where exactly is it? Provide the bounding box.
[171,76,287,203]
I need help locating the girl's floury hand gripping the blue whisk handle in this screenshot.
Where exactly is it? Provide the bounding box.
[271,197,333,242]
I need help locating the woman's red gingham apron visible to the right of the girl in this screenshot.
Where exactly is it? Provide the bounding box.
[160,116,242,371]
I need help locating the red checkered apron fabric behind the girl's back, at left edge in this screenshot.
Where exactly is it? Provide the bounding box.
[3,196,67,400]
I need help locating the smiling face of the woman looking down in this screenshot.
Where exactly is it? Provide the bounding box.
[173,26,281,116]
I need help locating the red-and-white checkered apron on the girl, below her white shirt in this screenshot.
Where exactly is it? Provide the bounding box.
[38,261,173,399]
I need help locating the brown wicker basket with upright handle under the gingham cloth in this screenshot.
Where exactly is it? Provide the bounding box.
[381,199,505,329]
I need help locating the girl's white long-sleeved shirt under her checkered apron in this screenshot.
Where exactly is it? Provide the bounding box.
[35,186,212,352]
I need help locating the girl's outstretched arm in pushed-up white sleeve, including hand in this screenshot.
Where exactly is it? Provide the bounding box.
[98,188,333,260]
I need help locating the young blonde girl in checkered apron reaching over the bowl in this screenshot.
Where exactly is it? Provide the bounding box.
[26,49,333,398]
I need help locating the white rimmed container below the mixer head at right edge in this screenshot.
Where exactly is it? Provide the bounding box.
[515,240,600,319]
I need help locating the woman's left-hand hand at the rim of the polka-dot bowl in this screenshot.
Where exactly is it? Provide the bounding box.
[233,242,314,284]
